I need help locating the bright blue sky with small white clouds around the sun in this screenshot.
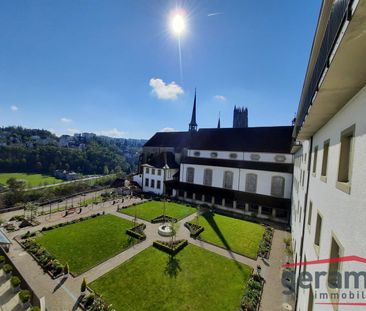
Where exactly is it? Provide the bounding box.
[0,0,321,138]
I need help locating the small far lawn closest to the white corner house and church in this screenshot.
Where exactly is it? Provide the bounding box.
[121,201,196,221]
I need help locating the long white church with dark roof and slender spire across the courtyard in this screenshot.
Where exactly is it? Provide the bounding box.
[134,94,293,224]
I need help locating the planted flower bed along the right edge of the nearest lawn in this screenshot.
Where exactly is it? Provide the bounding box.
[241,274,264,311]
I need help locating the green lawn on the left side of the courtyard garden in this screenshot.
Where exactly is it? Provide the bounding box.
[37,215,136,274]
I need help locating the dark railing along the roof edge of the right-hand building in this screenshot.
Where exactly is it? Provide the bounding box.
[296,0,352,134]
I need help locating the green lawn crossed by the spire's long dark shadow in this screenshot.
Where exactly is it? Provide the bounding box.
[199,213,264,259]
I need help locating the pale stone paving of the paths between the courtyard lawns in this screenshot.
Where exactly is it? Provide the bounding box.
[0,198,291,311]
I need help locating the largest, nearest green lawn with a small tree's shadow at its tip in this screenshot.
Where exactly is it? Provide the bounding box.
[89,244,251,311]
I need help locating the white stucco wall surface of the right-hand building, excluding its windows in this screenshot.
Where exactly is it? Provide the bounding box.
[293,87,366,311]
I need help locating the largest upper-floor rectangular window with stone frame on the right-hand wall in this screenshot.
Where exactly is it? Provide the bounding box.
[337,125,355,193]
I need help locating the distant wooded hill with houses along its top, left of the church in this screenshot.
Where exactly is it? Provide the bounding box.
[0,127,145,174]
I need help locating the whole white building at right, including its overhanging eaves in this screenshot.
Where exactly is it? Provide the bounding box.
[291,1,366,311]
